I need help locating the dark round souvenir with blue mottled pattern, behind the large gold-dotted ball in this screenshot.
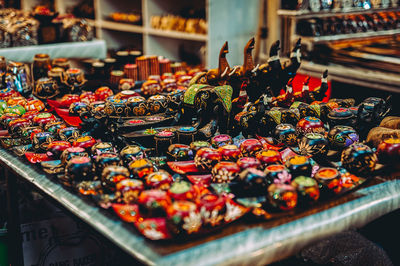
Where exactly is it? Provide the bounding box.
[328,126,359,150]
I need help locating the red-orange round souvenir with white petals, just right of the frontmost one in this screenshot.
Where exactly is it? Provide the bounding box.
[197,193,227,226]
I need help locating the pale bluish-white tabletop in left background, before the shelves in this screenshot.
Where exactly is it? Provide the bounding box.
[0,40,107,62]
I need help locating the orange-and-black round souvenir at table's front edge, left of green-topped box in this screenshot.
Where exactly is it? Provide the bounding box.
[268,184,297,211]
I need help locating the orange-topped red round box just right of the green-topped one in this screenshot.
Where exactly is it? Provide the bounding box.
[314,167,342,193]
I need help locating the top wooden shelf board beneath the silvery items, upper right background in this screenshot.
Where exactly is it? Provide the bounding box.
[278,7,400,19]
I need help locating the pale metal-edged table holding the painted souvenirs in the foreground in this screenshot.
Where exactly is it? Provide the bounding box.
[0,149,400,265]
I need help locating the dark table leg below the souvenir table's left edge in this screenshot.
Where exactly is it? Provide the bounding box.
[4,169,24,266]
